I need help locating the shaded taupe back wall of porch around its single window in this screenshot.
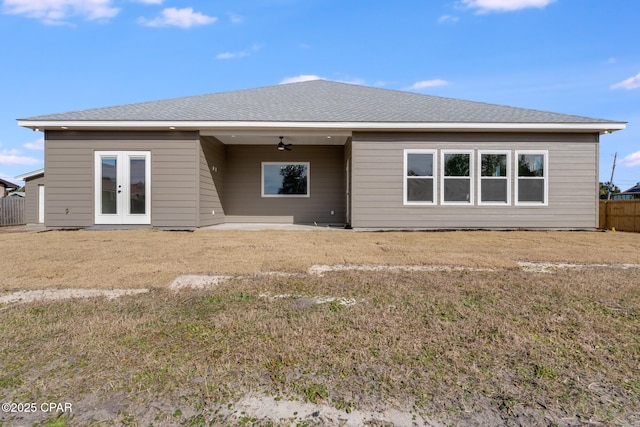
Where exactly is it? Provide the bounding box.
[224,143,346,224]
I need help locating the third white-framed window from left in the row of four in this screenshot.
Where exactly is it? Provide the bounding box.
[478,151,511,206]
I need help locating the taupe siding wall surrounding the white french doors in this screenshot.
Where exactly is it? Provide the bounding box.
[45,131,199,228]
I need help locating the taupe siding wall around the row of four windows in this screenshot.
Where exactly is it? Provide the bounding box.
[351,133,598,229]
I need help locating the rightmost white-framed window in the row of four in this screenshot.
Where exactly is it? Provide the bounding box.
[516,151,549,206]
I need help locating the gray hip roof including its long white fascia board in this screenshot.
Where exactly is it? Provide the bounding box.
[18,80,625,132]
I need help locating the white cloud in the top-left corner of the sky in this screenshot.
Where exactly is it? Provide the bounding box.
[3,0,120,25]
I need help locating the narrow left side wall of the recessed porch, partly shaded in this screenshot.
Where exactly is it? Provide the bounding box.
[198,136,226,227]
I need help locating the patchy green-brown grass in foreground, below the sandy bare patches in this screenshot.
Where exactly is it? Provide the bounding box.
[0,268,640,425]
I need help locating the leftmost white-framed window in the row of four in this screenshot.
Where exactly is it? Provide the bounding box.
[404,150,436,205]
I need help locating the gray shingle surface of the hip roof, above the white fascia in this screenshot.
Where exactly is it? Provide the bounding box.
[19,80,624,128]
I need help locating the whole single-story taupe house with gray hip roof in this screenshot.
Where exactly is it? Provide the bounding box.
[18,80,625,229]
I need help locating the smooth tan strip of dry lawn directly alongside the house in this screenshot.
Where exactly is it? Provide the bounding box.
[0,230,640,292]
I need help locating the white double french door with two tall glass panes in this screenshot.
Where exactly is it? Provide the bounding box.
[95,151,151,224]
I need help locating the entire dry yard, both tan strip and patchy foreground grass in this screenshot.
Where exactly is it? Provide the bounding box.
[0,230,640,426]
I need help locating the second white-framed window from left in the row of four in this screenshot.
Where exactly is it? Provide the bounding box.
[442,150,473,205]
